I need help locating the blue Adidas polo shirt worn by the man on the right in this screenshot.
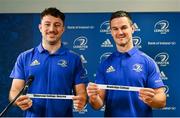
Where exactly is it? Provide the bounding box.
[96,47,164,117]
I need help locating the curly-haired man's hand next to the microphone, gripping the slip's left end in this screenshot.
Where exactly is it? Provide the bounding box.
[15,95,32,110]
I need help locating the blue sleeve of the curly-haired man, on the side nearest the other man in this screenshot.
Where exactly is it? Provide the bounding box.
[75,57,88,85]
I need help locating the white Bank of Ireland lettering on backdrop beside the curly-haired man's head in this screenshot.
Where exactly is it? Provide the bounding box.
[67,25,95,30]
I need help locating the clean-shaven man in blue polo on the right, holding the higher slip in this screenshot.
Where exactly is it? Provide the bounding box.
[87,11,166,117]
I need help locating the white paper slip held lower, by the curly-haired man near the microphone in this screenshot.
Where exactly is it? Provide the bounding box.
[26,94,74,99]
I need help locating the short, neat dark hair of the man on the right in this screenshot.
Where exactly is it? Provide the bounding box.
[110,10,133,24]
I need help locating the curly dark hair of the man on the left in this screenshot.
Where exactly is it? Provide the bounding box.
[41,7,65,23]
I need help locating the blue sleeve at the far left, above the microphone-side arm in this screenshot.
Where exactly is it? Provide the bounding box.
[10,54,25,79]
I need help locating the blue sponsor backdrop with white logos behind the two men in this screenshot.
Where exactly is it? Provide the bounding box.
[0,12,180,117]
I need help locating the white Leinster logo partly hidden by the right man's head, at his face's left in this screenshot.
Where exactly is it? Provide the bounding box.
[100,21,111,34]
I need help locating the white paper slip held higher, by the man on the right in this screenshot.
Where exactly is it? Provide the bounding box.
[97,84,142,91]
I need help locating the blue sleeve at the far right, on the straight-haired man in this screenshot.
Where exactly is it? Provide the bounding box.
[147,59,164,88]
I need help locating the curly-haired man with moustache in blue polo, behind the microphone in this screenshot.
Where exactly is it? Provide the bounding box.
[9,8,87,117]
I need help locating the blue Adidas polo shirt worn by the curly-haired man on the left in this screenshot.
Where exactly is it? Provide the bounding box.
[10,44,88,117]
